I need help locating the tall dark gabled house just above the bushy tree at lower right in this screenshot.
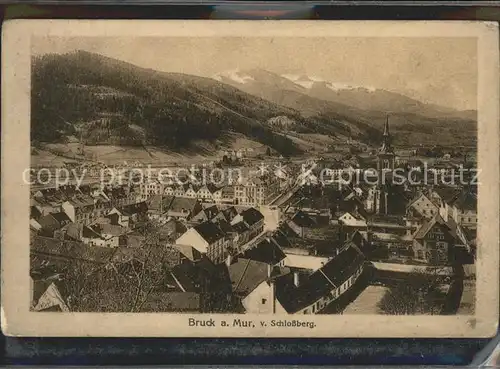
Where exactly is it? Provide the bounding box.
[413,214,455,265]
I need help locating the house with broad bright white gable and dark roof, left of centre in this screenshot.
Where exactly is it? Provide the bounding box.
[175,222,228,264]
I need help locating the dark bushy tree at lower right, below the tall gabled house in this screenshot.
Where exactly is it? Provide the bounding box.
[378,267,450,315]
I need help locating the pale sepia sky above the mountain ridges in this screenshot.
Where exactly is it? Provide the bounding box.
[32,36,478,110]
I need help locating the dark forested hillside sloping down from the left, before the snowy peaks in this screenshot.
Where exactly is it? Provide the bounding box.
[31,51,304,154]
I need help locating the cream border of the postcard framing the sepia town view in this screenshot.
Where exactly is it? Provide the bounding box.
[1,20,500,337]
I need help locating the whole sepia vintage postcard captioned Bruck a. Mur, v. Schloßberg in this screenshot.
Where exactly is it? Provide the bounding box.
[2,20,500,337]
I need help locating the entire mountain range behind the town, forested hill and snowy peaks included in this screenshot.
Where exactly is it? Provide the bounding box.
[31,51,476,155]
